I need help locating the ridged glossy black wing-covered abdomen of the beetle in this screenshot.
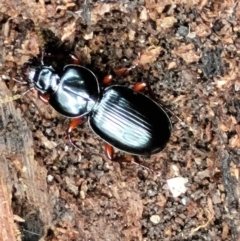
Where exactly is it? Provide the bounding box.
[89,85,172,155]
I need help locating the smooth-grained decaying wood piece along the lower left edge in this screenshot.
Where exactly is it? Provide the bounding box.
[0,81,52,241]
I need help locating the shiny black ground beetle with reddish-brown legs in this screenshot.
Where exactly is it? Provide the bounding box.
[24,53,172,169]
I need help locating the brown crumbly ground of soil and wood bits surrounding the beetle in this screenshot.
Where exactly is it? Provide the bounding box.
[0,0,240,241]
